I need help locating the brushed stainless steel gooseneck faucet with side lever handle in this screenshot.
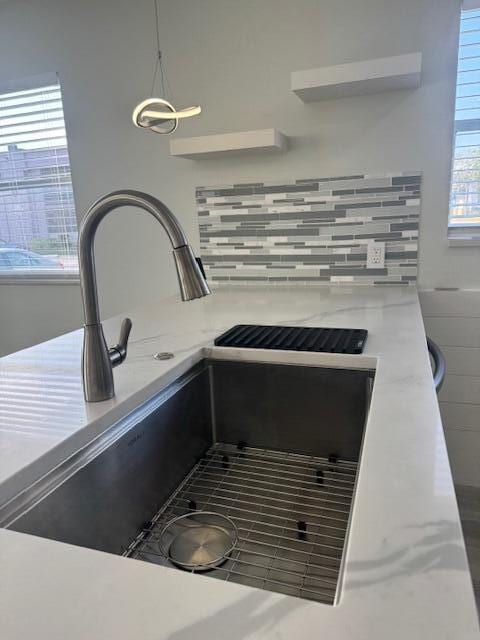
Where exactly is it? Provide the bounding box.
[78,190,210,402]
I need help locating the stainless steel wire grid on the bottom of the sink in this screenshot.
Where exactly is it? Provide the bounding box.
[124,443,357,604]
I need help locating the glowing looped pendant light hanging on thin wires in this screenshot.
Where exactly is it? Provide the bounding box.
[132,0,202,133]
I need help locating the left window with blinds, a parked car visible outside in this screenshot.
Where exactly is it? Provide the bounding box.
[0,74,78,276]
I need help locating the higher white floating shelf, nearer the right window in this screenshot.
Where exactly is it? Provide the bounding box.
[291,53,422,102]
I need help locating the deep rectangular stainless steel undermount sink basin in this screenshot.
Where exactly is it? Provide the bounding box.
[3,360,374,604]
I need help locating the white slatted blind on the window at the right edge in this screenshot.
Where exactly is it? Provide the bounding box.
[449,9,480,228]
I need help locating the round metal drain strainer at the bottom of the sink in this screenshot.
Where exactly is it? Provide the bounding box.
[160,511,238,571]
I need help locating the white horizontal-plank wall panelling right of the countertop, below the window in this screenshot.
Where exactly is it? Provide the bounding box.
[420,290,480,487]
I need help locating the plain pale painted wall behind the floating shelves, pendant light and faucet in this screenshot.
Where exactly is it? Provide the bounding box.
[0,0,480,352]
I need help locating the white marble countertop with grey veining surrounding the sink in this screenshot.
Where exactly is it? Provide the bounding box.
[0,286,480,640]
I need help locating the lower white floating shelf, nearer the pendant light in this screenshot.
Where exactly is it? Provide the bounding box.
[170,129,287,160]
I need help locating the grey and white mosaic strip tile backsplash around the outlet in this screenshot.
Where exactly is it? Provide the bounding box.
[196,172,421,285]
